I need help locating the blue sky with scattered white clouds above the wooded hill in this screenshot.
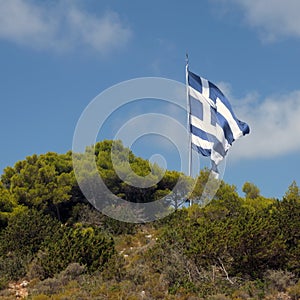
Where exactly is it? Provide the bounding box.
[0,0,300,198]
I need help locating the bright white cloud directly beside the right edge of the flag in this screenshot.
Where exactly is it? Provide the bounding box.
[229,90,300,159]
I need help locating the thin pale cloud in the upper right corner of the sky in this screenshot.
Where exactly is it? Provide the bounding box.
[220,0,300,41]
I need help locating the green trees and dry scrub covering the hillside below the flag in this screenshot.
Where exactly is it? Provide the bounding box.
[0,141,300,300]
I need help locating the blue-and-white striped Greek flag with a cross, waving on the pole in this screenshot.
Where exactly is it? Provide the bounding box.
[186,66,250,177]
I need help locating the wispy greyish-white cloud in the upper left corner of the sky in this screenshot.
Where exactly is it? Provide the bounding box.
[0,0,131,54]
